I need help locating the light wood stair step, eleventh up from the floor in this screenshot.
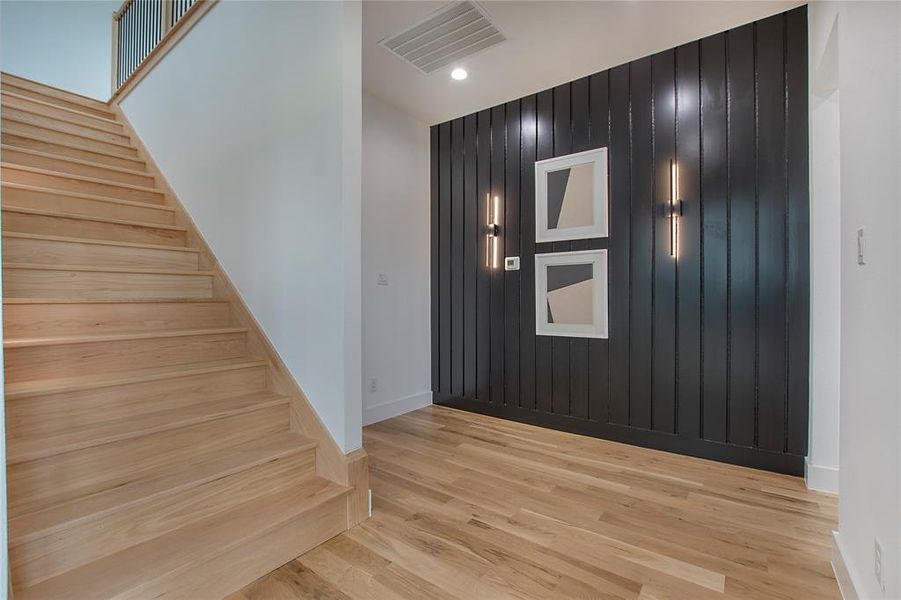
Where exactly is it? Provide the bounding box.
[0,162,166,204]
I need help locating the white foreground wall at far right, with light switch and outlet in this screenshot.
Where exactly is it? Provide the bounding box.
[811,2,901,598]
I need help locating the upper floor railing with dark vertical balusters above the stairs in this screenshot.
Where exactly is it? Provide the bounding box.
[112,0,202,94]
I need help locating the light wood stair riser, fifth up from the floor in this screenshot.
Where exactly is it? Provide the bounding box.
[4,333,247,383]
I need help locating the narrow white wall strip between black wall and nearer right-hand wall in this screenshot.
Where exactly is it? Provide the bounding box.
[806,10,841,493]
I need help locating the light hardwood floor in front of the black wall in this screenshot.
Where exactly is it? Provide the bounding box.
[229,407,839,600]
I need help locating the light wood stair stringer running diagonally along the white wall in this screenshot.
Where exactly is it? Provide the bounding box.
[109,100,369,529]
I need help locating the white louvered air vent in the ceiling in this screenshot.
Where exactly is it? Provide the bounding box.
[379,2,507,73]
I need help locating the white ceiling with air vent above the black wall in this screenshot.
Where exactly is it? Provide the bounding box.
[363,0,804,125]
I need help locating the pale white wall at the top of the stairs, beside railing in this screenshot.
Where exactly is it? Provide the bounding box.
[0,0,122,101]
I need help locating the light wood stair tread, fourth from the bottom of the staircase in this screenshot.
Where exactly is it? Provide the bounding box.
[6,358,268,401]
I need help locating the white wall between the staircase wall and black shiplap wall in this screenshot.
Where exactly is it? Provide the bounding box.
[363,94,432,425]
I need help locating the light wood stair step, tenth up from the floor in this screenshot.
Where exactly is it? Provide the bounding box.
[0,183,175,225]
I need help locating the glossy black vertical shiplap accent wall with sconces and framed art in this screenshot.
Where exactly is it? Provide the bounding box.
[431,7,809,474]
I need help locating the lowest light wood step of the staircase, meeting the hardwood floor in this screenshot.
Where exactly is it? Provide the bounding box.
[16,477,349,600]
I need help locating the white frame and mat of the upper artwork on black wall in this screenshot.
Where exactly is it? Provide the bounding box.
[535,148,608,242]
